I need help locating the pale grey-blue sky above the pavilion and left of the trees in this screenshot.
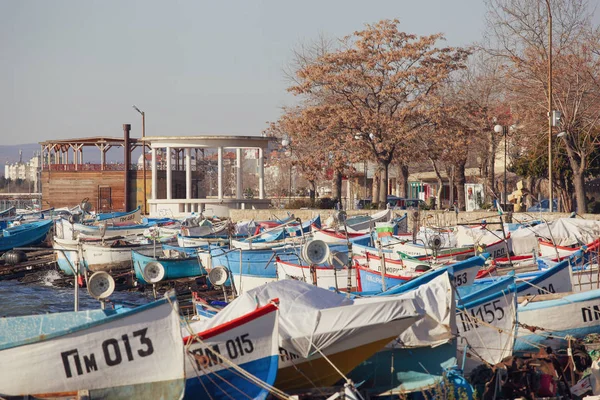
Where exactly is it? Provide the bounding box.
[0,0,502,145]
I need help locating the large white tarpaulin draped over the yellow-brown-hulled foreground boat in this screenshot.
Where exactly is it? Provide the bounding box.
[192,279,424,358]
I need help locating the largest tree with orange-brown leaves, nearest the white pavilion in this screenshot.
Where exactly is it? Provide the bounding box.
[288,20,469,205]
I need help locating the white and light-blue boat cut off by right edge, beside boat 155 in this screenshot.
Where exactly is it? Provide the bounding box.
[515,289,600,351]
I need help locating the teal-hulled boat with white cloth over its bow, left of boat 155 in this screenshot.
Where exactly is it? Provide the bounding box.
[348,271,472,398]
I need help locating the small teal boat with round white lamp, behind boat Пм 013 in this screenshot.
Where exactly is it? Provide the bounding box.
[131,249,206,285]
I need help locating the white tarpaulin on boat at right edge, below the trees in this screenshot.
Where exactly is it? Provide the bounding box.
[511,218,600,255]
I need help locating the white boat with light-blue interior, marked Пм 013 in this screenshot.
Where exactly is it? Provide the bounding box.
[0,292,185,399]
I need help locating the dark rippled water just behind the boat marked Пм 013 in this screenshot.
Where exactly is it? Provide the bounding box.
[0,271,152,317]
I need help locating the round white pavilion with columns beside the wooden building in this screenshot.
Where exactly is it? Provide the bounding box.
[140,136,270,216]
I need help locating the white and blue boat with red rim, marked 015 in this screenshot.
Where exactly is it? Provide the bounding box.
[183,304,279,400]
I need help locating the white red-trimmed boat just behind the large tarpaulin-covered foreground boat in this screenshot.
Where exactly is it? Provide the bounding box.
[277,260,357,291]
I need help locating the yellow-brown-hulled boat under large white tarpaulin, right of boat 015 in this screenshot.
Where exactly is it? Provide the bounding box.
[192,279,422,391]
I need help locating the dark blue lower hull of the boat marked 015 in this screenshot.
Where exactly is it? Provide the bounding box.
[184,355,278,400]
